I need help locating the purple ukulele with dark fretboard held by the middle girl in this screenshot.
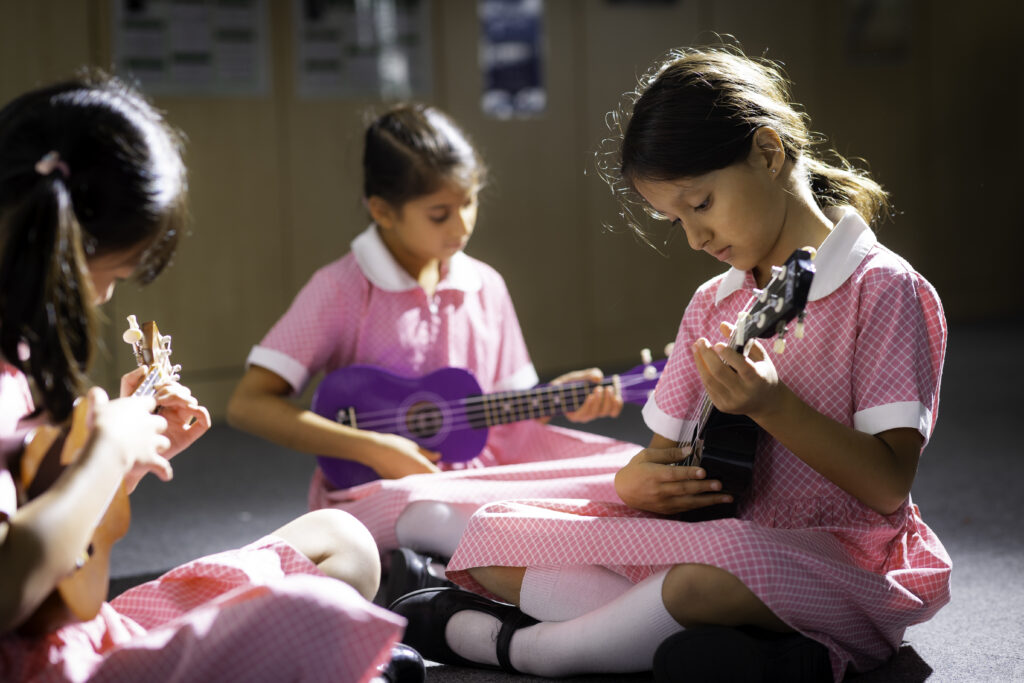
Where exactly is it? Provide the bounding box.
[312,349,665,488]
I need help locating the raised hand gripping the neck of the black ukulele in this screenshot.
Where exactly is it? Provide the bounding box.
[692,323,782,418]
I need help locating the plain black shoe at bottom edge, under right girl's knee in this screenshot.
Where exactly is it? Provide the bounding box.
[654,626,833,683]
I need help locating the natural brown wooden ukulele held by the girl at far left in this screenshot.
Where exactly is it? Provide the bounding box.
[20,315,180,633]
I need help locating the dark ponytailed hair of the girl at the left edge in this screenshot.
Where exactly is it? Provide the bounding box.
[0,74,186,420]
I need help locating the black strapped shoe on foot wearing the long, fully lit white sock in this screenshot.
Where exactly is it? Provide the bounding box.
[390,588,538,674]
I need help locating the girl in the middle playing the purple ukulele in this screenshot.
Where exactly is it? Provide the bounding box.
[228,101,637,597]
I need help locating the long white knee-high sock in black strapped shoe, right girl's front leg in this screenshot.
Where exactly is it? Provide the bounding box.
[444,571,683,678]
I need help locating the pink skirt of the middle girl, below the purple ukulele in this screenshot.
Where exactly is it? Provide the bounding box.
[309,421,642,553]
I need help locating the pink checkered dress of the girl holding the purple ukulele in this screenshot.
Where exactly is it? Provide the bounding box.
[248,226,639,551]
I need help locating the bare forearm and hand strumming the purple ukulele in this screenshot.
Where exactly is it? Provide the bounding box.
[227,366,437,478]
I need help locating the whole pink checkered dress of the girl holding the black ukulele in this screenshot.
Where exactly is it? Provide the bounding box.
[449,212,951,679]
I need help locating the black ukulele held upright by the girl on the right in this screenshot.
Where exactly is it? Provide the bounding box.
[676,247,815,521]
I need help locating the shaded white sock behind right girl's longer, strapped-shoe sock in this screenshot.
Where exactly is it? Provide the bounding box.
[519,564,633,622]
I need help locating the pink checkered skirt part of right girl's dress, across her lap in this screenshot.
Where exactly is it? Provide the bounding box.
[449,493,950,680]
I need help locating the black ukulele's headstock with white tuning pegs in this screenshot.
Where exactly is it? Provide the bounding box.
[731,247,816,353]
